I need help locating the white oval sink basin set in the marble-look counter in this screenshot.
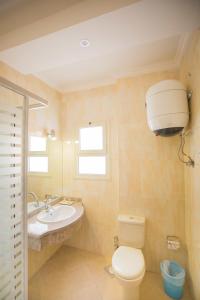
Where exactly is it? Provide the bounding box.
[37,205,76,223]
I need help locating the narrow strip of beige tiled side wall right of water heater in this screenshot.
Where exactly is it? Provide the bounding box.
[180,30,200,300]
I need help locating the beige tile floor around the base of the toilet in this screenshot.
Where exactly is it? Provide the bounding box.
[29,246,191,300]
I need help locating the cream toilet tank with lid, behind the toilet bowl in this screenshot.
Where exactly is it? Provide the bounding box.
[118,215,145,249]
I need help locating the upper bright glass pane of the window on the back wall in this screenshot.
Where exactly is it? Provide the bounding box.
[80,126,103,150]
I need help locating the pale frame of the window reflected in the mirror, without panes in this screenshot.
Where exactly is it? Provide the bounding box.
[28,134,50,177]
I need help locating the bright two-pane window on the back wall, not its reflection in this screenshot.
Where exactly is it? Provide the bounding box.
[77,125,108,177]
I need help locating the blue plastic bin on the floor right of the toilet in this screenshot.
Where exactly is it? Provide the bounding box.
[160,260,185,300]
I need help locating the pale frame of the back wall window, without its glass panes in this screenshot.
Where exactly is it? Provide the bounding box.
[75,122,110,180]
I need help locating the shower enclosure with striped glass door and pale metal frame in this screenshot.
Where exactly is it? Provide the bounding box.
[0,77,48,300]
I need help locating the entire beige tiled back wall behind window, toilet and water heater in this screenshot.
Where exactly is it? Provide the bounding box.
[62,72,186,271]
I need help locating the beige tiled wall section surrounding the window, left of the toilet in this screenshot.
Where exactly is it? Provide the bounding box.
[63,86,119,254]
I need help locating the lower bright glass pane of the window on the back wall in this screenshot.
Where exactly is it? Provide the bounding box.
[78,156,106,175]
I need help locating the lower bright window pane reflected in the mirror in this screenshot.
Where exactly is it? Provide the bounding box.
[28,156,48,173]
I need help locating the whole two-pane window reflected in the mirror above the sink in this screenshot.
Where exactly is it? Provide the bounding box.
[28,136,49,174]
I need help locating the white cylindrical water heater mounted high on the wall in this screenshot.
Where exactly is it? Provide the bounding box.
[146,80,189,136]
